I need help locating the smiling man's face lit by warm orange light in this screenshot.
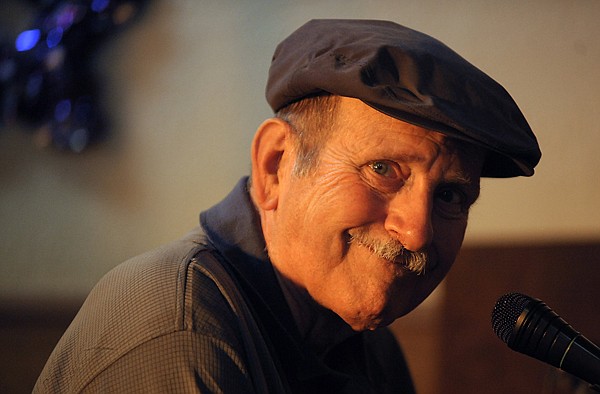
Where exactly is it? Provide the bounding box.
[267,98,483,330]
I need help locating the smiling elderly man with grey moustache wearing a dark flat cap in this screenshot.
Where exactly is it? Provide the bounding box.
[35,20,540,393]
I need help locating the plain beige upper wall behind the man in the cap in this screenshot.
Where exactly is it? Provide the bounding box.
[0,0,600,298]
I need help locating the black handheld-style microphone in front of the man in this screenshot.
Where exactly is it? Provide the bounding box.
[492,293,600,390]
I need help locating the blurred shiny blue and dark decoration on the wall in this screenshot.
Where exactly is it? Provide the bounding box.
[0,0,147,152]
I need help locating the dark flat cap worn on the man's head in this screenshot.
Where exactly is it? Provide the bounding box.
[266,19,541,178]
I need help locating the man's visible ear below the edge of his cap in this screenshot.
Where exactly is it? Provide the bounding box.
[251,118,291,211]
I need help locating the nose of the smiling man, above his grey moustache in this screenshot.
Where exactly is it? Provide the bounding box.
[384,188,433,252]
